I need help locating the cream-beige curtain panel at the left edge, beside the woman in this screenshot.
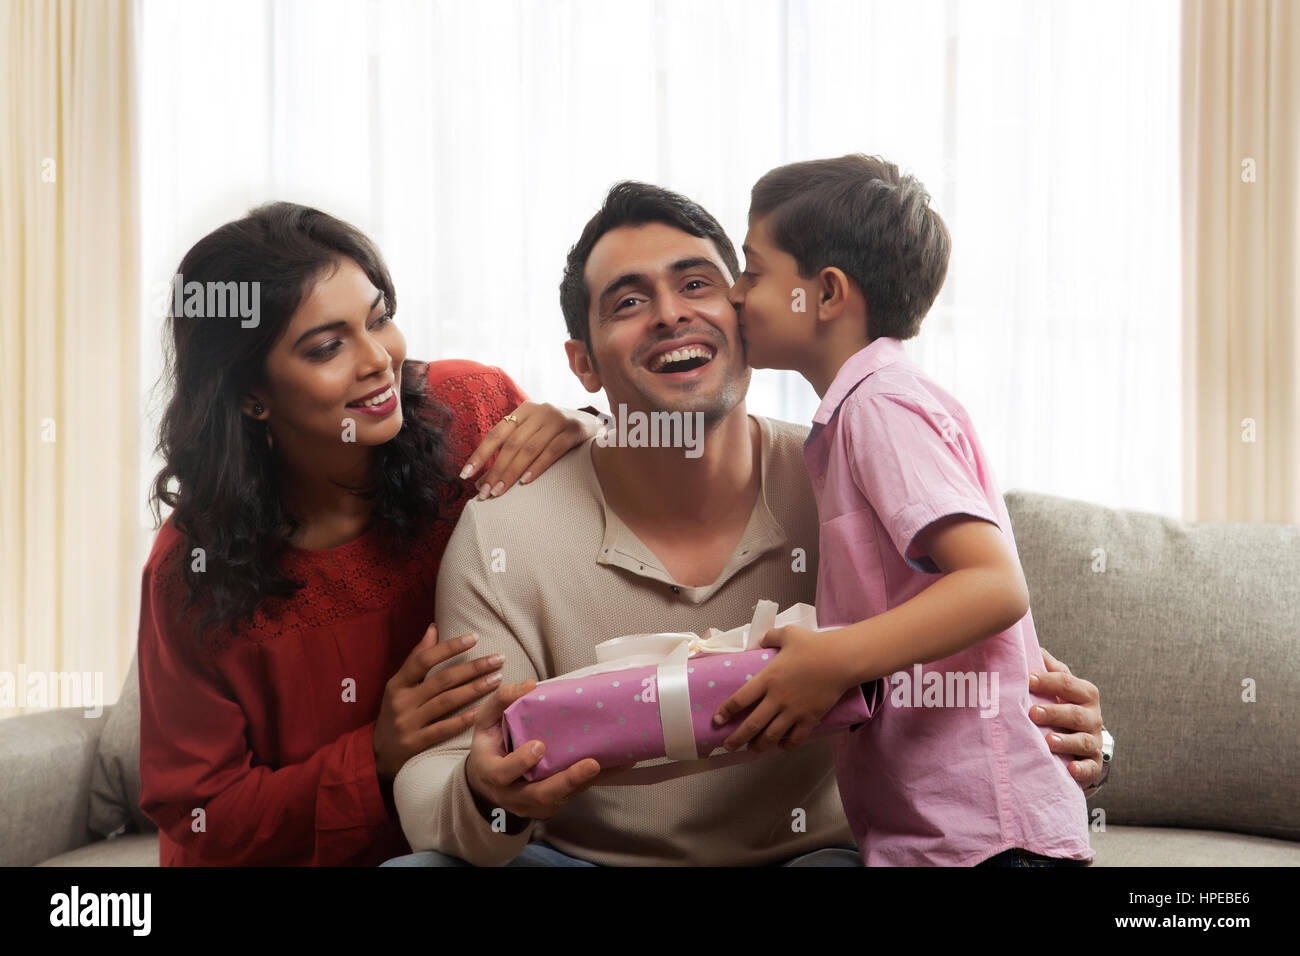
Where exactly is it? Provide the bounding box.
[0,0,147,717]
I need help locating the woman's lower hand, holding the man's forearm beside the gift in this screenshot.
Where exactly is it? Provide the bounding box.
[374,624,503,782]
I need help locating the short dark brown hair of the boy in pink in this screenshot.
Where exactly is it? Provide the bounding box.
[749,153,952,338]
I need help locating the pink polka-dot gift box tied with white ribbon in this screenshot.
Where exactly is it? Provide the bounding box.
[502,601,883,783]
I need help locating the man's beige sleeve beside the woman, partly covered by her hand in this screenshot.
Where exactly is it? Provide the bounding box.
[393,501,540,866]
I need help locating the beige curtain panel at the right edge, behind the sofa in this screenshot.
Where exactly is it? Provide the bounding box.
[1182,0,1300,523]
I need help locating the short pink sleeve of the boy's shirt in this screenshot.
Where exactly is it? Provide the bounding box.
[841,394,997,574]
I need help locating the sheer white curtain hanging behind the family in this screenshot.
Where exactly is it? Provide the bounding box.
[142,0,1180,556]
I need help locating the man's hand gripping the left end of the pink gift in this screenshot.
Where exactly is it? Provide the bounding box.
[465,680,601,819]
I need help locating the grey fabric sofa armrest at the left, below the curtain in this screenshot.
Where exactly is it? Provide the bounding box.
[0,708,111,866]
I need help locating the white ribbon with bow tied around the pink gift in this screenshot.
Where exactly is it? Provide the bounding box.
[530,601,831,761]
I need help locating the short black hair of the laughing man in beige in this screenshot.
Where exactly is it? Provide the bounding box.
[560,179,740,360]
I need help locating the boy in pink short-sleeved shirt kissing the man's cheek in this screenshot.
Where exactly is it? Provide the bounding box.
[715,155,1093,865]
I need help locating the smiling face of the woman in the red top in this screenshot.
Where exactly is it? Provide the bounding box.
[244,259,406,449]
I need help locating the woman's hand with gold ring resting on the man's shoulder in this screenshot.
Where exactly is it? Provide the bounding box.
[460,402,602,501]
